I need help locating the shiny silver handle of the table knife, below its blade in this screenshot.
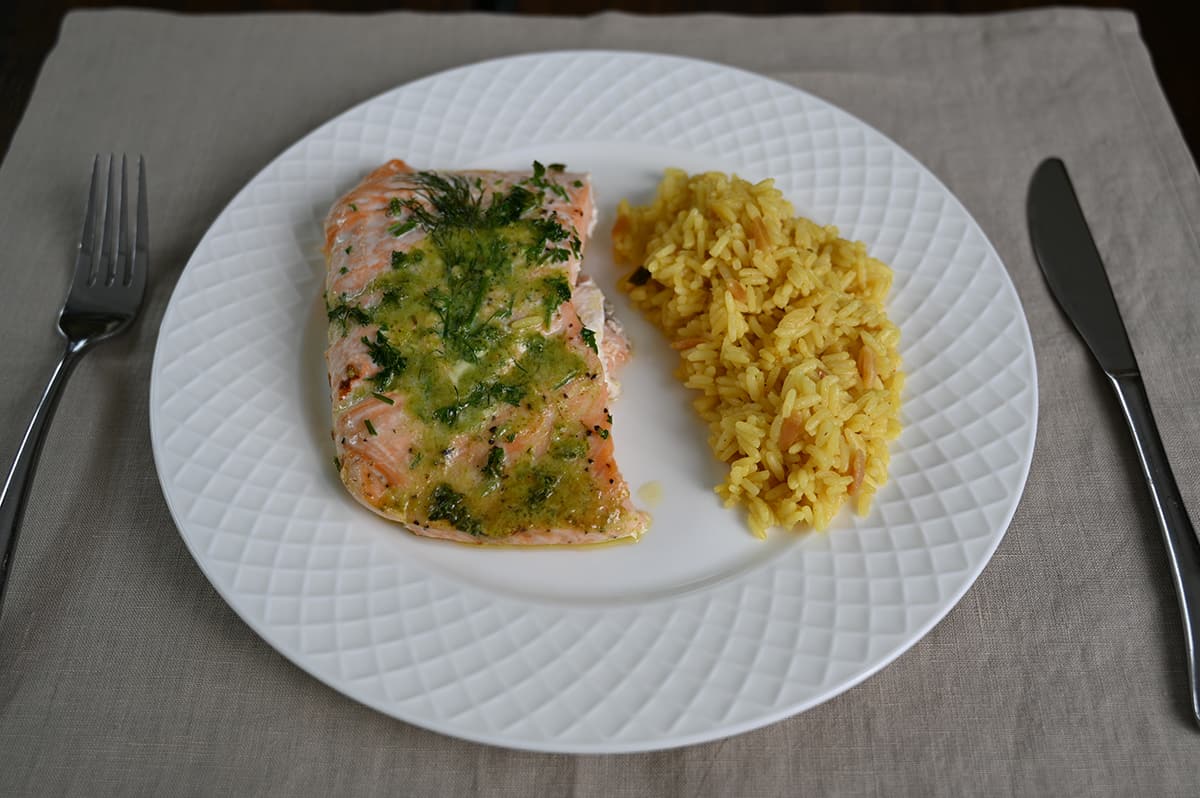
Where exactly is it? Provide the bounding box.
[1108,373,1200,724]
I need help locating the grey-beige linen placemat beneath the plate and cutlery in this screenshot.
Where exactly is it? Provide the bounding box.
[0,10,1200,796]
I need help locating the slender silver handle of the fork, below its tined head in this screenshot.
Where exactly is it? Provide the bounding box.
[0,343,83,608]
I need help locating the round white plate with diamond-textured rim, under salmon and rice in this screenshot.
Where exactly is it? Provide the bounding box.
[150,52,1037,752]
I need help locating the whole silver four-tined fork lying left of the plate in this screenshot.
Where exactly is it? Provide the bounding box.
[0,155,150,606]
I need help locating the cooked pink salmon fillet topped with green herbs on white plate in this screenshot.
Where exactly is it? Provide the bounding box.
[325,161,648,545]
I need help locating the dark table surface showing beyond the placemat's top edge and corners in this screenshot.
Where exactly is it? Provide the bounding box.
[0,0,1200,165]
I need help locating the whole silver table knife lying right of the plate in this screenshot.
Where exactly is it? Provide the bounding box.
[1026,158,1200,724]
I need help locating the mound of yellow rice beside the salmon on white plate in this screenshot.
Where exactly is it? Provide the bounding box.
[612,169,904,536]
